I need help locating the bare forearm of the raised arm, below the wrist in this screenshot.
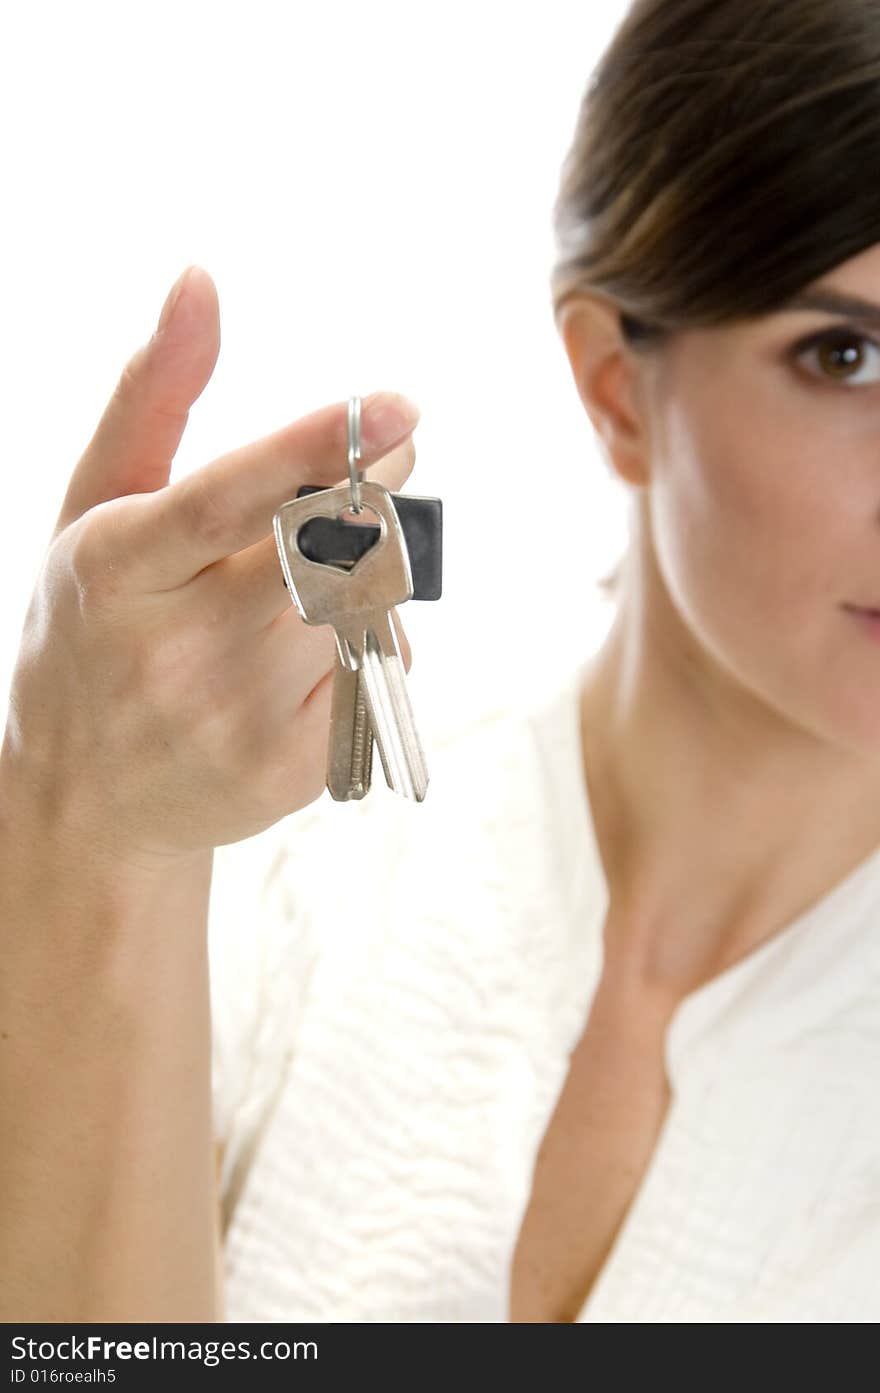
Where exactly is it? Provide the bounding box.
[0,780,221,1322]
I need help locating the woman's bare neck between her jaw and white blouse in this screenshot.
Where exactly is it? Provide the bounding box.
[581,576,880,999]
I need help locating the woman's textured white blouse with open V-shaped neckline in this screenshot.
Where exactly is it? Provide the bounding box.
[209,670,880,1322]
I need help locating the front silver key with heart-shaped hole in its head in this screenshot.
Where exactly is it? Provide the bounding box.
[273,481,427,802]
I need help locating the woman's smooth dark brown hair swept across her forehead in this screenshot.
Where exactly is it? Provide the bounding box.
[551,0,880,589]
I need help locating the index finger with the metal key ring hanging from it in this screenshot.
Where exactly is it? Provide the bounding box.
[117,391,419,591]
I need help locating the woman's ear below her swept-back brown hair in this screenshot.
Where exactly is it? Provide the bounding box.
[557,293,649,488]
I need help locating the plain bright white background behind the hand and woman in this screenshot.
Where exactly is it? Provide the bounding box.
[0,0,627,752]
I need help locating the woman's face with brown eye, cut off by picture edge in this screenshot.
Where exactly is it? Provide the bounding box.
[643,244,880,755]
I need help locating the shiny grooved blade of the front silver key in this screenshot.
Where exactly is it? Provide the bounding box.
[361,610,427,802]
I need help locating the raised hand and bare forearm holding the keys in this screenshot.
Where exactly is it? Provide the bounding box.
[0,269,418,1322]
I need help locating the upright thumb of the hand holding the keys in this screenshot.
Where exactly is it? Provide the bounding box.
[53,266,220,536]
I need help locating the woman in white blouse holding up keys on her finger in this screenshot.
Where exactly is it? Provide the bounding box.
[0,0,880,1322]
